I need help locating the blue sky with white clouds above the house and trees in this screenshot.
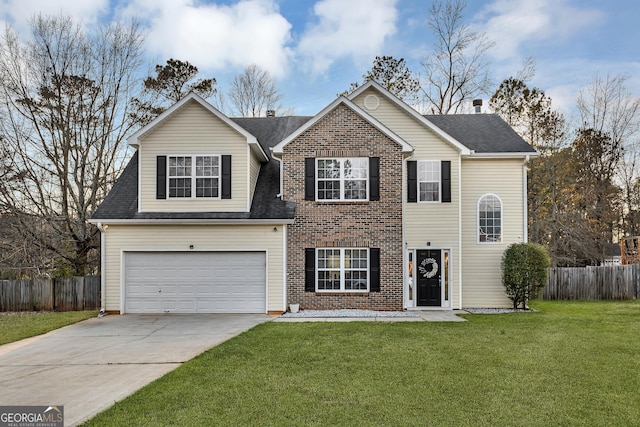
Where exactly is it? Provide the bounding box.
[0,0,640,116]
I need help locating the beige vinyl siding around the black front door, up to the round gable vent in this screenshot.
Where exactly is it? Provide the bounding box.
[354,89,460,308]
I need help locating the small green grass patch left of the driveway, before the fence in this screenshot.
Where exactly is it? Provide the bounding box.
[0,311,98,345]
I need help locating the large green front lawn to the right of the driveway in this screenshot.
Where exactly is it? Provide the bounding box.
[86,302,640,426]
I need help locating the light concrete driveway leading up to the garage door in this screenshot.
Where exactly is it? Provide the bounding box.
[0,314,274,426]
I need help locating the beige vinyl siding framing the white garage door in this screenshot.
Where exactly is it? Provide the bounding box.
[103,224,286,311]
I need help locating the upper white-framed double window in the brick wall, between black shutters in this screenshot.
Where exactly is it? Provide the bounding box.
[316,157,369,201]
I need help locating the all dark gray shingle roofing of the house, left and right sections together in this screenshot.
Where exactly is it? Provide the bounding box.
[92,114,535,220]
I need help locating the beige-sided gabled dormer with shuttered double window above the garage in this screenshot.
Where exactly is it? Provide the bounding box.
[127,93,269,213]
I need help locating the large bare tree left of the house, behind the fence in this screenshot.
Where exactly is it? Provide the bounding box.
[0,15,143,274]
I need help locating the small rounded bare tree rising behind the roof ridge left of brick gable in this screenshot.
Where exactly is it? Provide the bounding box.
[228,64,283,117]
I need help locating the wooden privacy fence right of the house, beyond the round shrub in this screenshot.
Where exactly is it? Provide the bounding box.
[542,264,640,300]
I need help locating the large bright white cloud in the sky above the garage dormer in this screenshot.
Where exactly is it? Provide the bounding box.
[118,0,291,77]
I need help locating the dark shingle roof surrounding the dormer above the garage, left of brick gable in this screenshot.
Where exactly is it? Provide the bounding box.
[91,117,310,223]
